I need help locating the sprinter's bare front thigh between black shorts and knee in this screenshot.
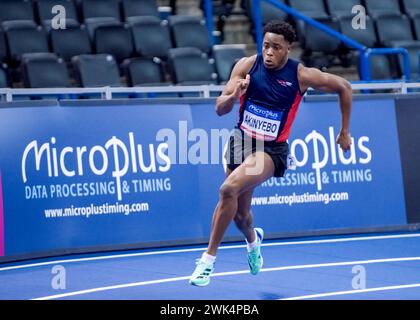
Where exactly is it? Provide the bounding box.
[224,151,274,198]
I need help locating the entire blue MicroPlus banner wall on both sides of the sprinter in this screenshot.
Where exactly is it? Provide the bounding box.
[0,100,406,257]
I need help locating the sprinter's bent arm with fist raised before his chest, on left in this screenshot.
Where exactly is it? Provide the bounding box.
[216,56,256,116]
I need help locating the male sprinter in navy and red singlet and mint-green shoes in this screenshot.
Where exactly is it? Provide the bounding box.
[190,21,352,286]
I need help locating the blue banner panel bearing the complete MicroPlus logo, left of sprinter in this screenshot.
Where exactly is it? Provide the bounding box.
[0,105,203,255]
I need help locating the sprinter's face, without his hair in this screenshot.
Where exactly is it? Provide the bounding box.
[262,32,291,69]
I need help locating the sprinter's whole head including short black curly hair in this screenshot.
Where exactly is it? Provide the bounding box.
[262,20,296,69]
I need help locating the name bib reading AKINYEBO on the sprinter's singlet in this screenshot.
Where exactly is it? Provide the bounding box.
[241,101,283,141]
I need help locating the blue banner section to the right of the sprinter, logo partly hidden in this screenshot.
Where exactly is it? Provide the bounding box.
[249,99,407,232]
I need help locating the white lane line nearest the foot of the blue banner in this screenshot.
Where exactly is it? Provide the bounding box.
[4,233,420,271]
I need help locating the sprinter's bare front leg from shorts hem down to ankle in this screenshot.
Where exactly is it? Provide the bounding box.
[207,152,274,256]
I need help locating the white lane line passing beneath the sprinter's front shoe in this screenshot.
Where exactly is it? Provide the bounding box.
[32,257,420,300]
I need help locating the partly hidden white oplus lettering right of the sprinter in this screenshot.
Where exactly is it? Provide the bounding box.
[290,127,372,190]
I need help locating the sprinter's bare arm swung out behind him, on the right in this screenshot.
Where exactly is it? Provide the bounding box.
[298,65,352,151]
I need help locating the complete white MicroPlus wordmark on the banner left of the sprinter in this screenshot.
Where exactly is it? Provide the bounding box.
[21,132,171,200]
